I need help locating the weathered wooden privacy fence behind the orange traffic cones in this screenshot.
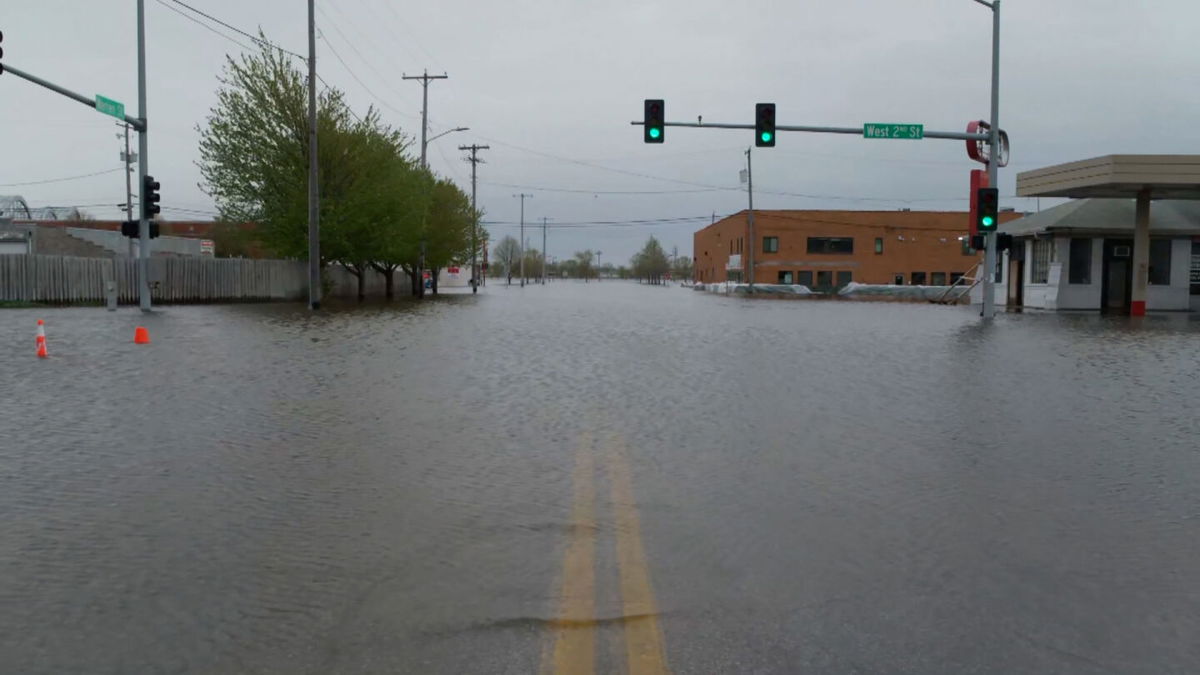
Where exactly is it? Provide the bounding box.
[0,255,308,304]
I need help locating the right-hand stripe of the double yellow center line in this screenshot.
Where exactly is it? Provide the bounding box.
[608,438,670,675]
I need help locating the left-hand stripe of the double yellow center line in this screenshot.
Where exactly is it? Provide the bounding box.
[542,434,596,675]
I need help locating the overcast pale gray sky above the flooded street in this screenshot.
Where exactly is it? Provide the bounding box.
[0,0,1200,262]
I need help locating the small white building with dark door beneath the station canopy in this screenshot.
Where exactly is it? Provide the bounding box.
[997,198,1200,313]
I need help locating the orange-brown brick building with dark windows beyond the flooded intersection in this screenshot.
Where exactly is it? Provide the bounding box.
[692,209,1020,289]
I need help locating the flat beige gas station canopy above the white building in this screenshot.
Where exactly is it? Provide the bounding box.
[1016,155,1200,199]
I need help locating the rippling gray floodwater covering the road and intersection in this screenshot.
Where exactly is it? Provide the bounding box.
[0,282,1200,675]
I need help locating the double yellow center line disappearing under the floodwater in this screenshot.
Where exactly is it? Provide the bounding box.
[542,434,670,675]
